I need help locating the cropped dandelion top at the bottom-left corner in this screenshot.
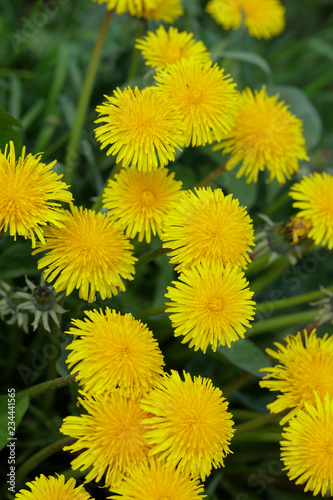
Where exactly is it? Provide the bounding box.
[15,474,92,500]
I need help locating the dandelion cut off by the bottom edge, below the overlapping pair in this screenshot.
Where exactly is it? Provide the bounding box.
[109,458,206,500]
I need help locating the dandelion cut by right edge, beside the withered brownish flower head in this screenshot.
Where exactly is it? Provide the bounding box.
[289,172,333,250]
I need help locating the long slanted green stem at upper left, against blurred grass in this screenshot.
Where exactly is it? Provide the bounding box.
[64,10,113,184]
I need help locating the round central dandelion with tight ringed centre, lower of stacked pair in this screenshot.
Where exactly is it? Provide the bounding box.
[165,263,255,352]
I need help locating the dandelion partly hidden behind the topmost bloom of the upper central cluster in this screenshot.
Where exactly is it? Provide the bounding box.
[135,26,210,69]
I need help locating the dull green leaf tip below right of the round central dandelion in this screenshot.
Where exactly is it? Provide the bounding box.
[216,339,271,378]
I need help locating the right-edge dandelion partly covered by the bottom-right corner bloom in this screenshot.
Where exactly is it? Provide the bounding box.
[260,330,333,425]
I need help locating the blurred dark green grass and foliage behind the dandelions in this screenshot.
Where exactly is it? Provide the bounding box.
[0,0,333,500]
